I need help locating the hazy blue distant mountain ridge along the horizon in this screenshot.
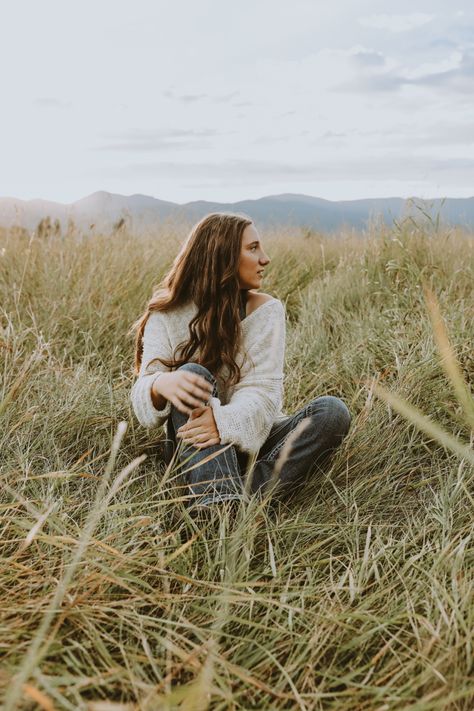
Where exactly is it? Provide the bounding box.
[0,191,474,232]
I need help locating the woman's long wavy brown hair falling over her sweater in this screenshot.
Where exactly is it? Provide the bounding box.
[130,212,252,384]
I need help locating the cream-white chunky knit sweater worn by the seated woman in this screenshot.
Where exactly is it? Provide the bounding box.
[131,298,287,452]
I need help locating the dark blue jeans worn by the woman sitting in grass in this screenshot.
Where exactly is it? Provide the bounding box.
[165,363,351,504]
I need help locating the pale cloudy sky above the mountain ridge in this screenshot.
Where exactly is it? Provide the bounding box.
[0,0,474,203]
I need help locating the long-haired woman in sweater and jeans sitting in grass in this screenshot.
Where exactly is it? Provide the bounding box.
[131,213,351,510]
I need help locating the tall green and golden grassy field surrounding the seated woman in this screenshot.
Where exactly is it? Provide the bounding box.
[0,221,474,711]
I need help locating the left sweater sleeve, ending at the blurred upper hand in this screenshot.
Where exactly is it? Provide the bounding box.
[130,311,172,427]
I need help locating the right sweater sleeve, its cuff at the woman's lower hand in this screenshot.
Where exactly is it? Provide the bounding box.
[209,299,285,452]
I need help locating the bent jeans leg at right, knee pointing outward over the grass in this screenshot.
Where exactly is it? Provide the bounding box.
[251,395,351,499]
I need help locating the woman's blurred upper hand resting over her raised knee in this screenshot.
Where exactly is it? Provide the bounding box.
[153,370,212,415]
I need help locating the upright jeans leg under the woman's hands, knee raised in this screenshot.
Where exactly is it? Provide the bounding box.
[168,363,243,505]
